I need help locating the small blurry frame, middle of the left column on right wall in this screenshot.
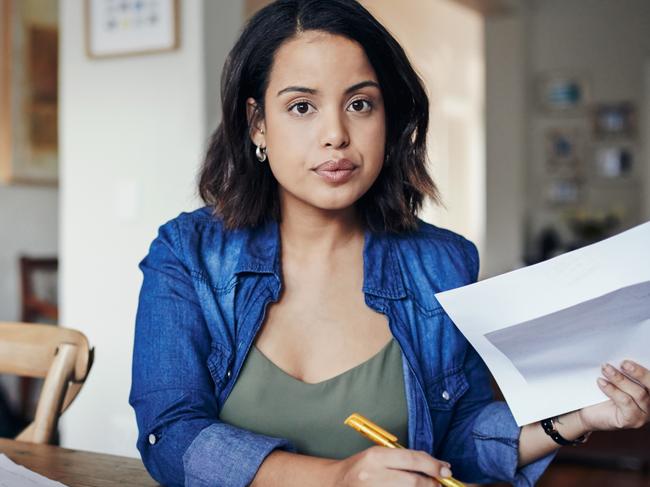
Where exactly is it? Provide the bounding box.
[545,128,584,178]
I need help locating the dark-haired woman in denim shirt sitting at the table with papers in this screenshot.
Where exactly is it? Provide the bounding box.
[130,0,650,487]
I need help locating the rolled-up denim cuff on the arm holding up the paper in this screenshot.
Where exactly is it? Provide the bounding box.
[472,402,556,487]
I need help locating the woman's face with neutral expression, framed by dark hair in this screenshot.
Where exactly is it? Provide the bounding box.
[248,31,386,214]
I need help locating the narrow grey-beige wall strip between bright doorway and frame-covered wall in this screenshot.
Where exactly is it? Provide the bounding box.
[481,3,528,277]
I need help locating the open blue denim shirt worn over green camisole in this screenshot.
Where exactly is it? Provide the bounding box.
[129,208,553,487]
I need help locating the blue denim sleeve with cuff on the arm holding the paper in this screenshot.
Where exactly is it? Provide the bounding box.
[437,347,555,487]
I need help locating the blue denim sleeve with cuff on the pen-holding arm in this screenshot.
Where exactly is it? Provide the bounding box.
[129,222,293,487]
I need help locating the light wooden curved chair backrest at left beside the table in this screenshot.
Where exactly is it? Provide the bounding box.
[0,322,94,443]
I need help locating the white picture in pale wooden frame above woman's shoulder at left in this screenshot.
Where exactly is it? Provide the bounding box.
[86,0,179,58]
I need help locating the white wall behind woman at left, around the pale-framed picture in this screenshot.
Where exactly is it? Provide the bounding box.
[60,0,242,456]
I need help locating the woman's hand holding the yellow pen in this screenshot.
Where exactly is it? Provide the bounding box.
[332,446,451,487]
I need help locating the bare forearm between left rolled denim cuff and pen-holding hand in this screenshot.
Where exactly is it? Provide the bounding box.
[251,450,337,487]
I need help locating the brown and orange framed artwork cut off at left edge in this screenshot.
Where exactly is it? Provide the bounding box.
[0,0,58,185]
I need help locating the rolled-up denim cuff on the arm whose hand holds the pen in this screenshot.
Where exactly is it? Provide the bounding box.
[183,423,295,487]
